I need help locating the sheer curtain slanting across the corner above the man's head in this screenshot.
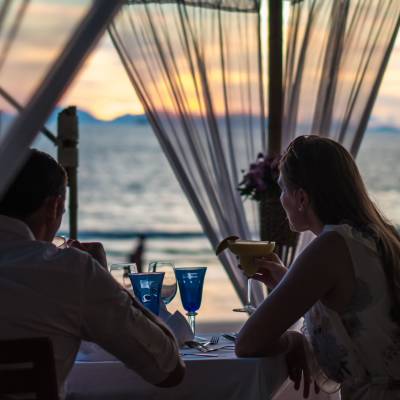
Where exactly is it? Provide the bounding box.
[0,0,122,196]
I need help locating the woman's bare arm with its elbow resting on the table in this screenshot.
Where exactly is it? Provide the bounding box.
[236,232,352,357]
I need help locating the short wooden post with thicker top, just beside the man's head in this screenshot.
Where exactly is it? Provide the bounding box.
[57,106,79,239]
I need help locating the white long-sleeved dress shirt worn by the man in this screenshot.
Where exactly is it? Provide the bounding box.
[0,215,181,391]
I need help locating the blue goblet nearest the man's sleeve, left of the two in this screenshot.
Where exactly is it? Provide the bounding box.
[129,272,164,315]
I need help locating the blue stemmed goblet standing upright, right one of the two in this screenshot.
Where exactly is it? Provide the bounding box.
[175,267,207,334]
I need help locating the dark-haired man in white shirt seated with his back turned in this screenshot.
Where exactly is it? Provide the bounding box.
[0,150,185,392]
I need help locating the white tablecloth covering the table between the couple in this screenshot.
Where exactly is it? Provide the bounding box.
[66,339,287,400]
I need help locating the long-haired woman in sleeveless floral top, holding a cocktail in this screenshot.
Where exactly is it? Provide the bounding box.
[236,136,400,400]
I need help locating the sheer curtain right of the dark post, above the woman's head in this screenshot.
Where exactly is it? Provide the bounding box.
[282,0,400,252]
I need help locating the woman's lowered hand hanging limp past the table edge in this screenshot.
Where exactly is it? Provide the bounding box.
[285,331,319,399]
